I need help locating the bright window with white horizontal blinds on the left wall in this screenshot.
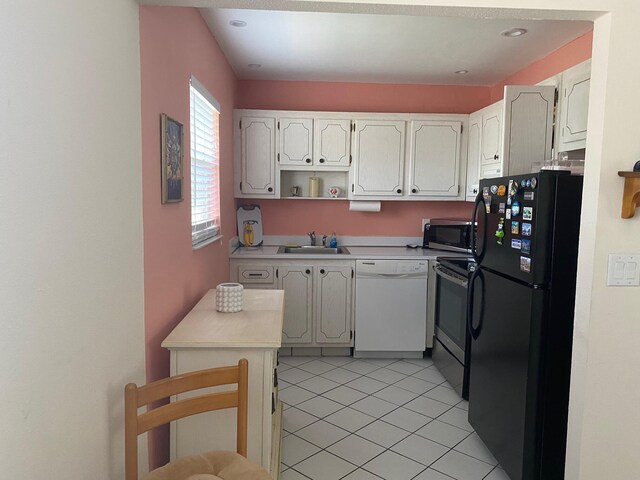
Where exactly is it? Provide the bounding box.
[190,77,220,248]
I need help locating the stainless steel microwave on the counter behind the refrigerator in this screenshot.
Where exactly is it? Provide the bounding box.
[422,218,476,253]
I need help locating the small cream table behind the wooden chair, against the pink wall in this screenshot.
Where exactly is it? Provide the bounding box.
[162,290,284,478]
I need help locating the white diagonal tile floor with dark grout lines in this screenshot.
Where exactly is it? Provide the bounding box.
[278,357,509,480]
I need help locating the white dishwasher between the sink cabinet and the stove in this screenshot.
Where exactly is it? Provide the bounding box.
[354,260,428,357]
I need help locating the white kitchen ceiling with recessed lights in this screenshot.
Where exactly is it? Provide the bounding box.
[201,8,593,85]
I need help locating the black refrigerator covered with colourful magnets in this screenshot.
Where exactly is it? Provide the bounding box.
[467,171,582,480]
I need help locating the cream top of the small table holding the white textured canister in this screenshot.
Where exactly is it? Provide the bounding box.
[162,289,284,350]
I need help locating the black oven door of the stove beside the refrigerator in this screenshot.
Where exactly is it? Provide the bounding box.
[434,264,469,365]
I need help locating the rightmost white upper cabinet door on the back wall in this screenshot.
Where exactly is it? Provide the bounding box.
[407,120,462,197]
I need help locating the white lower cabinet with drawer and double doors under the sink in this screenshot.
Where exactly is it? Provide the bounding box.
[230,259,355,347]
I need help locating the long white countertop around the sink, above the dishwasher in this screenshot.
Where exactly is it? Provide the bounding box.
[229,245,468,260]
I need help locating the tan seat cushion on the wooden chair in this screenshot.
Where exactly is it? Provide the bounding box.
[144,452,272,480]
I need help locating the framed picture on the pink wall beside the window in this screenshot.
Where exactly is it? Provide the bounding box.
[160,113,184,203]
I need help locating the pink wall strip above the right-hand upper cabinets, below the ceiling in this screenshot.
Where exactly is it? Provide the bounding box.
[491,31,593,103]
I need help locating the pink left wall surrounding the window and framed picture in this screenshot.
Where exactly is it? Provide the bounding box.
[140,7,237,468]
